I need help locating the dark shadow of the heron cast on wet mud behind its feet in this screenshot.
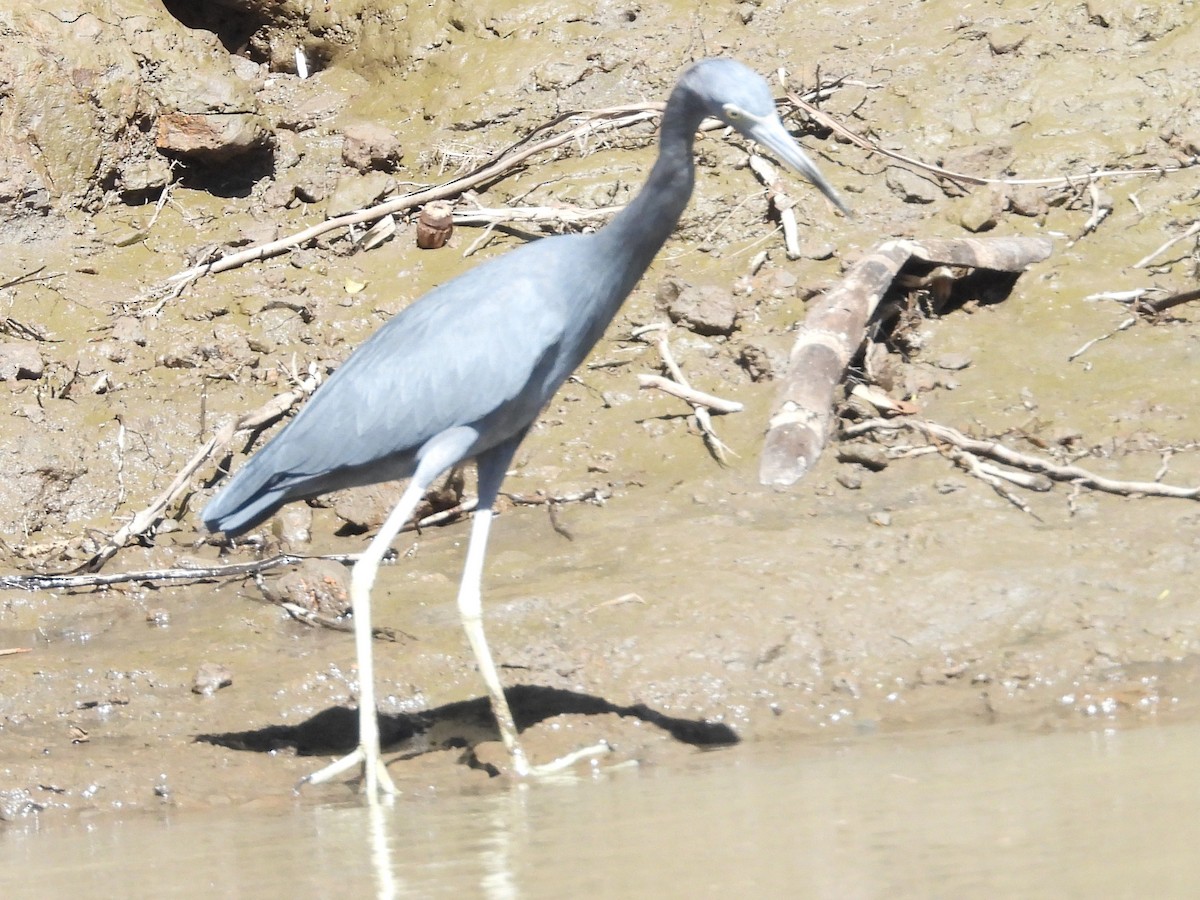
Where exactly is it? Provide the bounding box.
[196,685,739,775]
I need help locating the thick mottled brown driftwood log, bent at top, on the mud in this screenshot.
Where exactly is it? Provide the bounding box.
[758,238,1052,486]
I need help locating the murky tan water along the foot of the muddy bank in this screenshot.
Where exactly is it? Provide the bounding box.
[7,725,1200,900]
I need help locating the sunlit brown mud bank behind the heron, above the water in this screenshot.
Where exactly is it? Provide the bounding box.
[0,0,1200,820]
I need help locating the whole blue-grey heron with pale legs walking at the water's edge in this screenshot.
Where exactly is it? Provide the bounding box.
[203,59,846,799]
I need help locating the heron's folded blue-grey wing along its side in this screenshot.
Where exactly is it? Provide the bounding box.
[252,253,566,480]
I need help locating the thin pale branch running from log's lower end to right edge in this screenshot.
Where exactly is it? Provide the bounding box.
[845,419,1200,500]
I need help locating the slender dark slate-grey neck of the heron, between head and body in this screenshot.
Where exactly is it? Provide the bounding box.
[601,88,704,285]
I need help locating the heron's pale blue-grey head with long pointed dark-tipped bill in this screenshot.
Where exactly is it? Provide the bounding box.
[684,59,850,215]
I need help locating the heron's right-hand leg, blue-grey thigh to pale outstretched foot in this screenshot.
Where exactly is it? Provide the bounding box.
[458,432,610,778]
